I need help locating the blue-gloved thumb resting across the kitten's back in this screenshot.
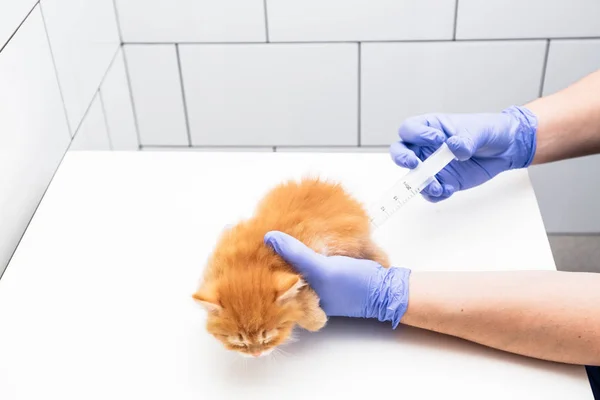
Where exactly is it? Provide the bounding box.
[264,231,324,278]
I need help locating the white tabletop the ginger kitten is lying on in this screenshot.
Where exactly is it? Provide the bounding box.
[0,152,592,400]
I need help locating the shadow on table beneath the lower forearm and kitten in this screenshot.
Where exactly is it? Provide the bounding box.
[219,318,581,384]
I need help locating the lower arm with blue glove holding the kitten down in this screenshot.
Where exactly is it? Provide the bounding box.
[265,232,600,365]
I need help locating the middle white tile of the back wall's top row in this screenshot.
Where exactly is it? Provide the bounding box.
[267,0,455,42]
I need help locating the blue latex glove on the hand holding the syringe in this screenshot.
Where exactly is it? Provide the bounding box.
[390,106,537,202]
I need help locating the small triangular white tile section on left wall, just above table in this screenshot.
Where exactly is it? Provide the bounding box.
[69,94,111,151]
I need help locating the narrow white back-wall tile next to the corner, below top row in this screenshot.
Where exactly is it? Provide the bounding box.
[124,45,189,145]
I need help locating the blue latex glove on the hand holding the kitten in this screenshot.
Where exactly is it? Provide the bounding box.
[265,231,410,329]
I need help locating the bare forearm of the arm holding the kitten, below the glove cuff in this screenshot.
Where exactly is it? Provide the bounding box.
[402,271,600,365]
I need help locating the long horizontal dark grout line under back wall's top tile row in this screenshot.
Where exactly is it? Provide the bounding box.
[123,36,600,46]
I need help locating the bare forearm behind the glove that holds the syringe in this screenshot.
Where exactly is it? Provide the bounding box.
[525,70,600,164]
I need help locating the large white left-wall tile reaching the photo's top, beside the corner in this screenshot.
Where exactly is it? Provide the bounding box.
[41,0,119,132]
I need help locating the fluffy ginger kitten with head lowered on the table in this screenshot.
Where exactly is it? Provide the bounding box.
[193,178,389,357]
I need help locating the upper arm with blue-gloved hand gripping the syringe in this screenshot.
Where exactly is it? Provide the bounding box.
[390,71,600,201]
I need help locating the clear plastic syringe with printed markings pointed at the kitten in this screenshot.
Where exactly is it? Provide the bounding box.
[369,143,455,229]
